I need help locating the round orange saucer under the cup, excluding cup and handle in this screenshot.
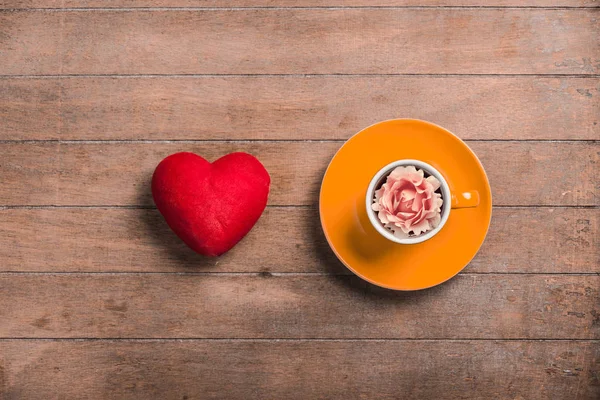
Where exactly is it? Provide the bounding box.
[319,119,492,290]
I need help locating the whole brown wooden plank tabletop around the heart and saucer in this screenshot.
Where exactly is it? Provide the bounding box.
[0,0,600,400]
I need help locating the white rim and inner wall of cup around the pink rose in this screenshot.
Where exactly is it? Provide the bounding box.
[366,159,452,244]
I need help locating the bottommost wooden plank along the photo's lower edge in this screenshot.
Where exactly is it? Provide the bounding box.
[0,341,600,400]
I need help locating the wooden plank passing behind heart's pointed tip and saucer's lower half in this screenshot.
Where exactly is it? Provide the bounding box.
[0,207,600,274]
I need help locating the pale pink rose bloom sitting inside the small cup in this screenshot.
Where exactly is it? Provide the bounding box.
[371,165,444,238]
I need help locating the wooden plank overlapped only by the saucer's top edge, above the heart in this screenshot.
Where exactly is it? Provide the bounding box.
[0,76,600,140]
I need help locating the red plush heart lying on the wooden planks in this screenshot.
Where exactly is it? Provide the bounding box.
[152,153,271,256]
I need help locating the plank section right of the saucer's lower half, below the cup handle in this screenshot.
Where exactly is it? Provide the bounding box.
[474,208,600,273]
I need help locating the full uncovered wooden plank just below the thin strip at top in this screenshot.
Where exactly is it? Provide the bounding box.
[0,8,600,75]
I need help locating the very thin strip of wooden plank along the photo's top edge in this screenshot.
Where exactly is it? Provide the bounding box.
[0,0,598,8]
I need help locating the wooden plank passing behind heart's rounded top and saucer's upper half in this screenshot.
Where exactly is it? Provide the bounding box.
[0,142,600,206]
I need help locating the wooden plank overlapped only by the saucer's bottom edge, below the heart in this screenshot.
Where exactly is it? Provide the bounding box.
[0,274,600,339]
